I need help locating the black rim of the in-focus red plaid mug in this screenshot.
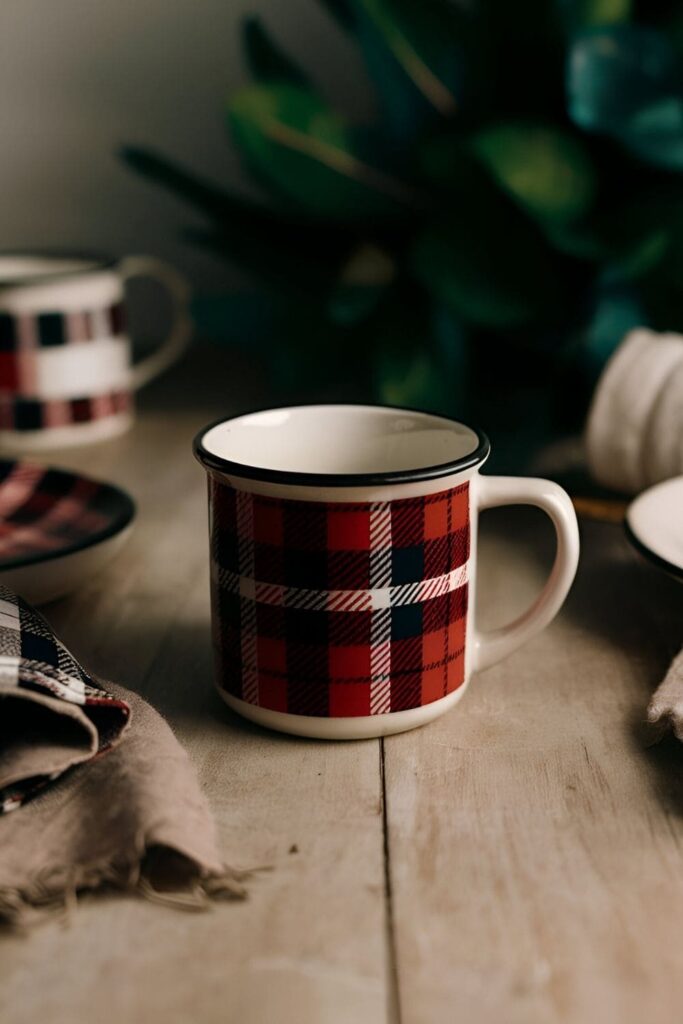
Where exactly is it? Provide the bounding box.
[193,401,490,487]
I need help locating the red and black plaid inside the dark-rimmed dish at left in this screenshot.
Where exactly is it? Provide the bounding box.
[0,460,133,570]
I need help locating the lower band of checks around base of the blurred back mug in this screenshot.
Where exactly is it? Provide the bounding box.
[0,391,132,431]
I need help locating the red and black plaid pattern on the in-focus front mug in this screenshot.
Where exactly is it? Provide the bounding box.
[209,477,469,718]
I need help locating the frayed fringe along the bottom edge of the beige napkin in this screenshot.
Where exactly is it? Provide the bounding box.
[0,844,252,930]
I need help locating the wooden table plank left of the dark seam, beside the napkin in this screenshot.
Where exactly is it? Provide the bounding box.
[0,354,388,1024]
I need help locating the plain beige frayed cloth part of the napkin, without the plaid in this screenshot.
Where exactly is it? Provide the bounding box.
[0,681,244,925]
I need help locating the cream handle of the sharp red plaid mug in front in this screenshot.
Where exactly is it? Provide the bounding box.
[474,476,579,671]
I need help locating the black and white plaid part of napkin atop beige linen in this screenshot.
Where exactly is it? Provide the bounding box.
[0,587,130,814]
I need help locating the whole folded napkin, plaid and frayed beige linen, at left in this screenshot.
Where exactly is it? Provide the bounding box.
[0,587,244,925]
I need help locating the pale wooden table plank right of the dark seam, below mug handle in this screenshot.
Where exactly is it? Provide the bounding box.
[385,512,683,1024]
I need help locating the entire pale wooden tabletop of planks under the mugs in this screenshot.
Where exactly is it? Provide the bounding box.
[0,348,683,1024]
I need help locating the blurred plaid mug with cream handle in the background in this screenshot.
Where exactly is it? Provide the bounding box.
[0,254,190,453]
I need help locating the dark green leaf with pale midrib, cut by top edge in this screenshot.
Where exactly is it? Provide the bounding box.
[354,0,463,136]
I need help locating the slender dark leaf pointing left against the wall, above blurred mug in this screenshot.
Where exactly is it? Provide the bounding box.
[122,146,354,293]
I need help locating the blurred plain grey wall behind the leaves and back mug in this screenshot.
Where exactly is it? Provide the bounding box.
[0,0,370,287]
